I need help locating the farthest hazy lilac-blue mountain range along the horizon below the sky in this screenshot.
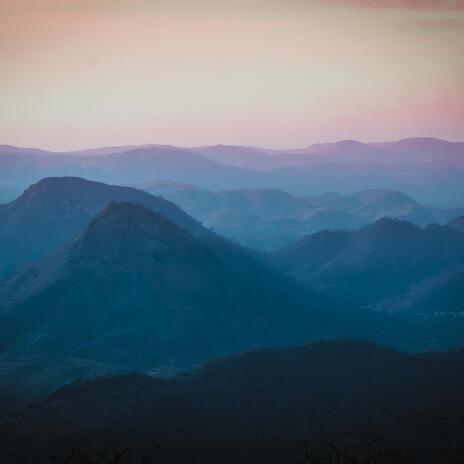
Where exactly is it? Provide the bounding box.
[0,138,464,205]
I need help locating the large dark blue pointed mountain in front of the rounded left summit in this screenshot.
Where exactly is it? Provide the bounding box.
[0,203,341,383]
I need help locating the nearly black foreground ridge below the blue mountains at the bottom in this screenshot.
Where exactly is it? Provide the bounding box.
[1,340,464,464]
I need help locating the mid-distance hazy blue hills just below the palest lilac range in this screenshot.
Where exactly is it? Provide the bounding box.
[137,182,464,251]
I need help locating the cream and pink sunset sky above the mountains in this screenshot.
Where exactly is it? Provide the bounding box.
[0,0,464,150]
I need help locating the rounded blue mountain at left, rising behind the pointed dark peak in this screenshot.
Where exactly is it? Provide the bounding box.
[0,177,207,277]
